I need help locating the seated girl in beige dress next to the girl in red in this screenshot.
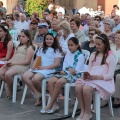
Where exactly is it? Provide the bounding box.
[0,30,34,99]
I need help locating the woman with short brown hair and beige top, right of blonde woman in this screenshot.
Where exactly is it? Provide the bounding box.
[70,18,86,44]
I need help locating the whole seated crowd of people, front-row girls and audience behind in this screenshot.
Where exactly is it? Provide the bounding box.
[0,2,120,120]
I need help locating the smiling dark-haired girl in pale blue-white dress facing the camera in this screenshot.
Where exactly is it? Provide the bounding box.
[23,33,62,106]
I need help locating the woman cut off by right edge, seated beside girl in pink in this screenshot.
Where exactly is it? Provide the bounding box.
[111,30,120,108]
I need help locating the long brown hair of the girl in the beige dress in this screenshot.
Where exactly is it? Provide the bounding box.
[17,29,34,49]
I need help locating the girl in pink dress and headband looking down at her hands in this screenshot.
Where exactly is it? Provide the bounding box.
[75,34,116,120]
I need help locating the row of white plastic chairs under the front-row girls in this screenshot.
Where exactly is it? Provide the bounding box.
[0,41,114,120]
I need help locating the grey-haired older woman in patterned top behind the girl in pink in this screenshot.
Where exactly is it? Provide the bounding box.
[104,18,115,45]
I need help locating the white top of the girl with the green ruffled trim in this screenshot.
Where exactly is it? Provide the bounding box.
[63,52,85,72]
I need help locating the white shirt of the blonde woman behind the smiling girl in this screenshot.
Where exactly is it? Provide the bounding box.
[59,33,75,53]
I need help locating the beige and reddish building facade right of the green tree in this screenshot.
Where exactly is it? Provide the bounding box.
[54,0,120,14]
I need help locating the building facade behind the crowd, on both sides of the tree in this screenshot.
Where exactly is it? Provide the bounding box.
[1,0,120,14]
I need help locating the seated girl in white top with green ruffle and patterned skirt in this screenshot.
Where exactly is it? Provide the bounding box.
[41,37,84,113]
